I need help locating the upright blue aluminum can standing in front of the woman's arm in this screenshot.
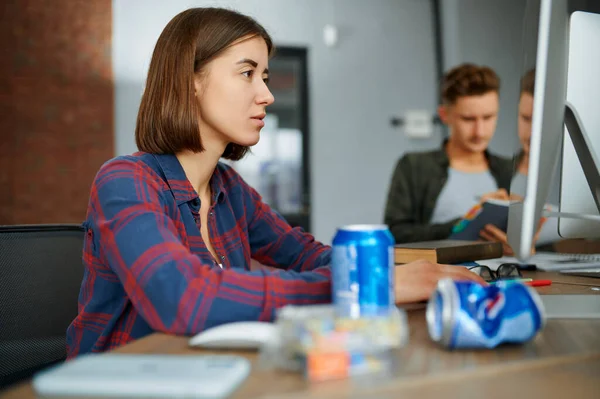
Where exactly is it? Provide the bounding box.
[331,225,394,319]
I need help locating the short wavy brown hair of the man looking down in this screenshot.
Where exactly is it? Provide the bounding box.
[441,63,500,104]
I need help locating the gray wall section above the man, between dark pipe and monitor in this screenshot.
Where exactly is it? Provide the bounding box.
[440,0,537,155]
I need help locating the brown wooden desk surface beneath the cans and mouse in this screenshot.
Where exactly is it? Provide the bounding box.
[0,272,600,399]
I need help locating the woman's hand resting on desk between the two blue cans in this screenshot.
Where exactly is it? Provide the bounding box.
[394,260,487,304]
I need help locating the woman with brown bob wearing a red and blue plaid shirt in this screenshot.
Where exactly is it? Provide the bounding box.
[67,8,482,357]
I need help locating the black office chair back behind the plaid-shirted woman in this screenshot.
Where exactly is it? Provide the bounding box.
[0,225,84,389]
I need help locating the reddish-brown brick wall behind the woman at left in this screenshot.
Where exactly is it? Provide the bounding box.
[0,0,114,224]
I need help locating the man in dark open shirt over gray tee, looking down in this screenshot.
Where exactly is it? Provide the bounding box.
[384,64,513,243]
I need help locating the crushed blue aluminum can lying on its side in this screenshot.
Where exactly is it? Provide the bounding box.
[426,279,546,349]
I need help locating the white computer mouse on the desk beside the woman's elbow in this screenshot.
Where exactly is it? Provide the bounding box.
[189,321,279,349]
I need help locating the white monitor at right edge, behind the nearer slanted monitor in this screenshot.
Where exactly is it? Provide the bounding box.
[558,11,600,238]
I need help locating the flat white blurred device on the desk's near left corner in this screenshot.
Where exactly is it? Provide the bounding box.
[33,352,251,399]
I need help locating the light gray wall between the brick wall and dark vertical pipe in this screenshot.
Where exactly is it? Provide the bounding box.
[113,0,440,243]
